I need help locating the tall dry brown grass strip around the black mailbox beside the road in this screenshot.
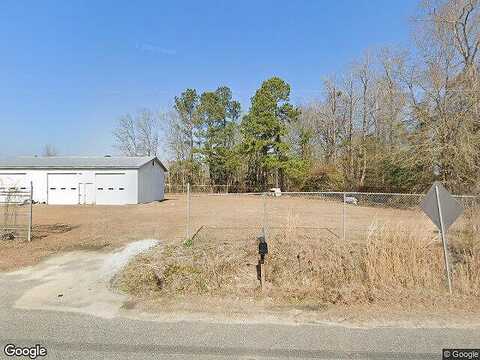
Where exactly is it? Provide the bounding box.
[117,207,480,308]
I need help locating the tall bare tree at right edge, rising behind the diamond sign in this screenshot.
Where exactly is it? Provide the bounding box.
[413,0,480,191]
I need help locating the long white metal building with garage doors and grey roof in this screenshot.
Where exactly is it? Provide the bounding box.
[0,156,167,205]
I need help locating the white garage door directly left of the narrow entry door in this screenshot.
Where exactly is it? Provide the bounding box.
[47,173,79,205]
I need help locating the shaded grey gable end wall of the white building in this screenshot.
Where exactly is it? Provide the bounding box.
[138,161,165,203]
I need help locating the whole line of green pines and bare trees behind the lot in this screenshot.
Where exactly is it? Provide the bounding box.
[114,0,480,193]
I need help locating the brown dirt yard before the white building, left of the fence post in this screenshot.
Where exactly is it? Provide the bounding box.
[0,197,185,271]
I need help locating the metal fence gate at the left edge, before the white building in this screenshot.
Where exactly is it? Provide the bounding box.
[0,184,33,241]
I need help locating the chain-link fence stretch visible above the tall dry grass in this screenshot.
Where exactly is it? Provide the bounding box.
[186,187,480,245]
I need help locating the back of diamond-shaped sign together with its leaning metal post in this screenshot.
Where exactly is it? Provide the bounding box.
[422,181,463,294]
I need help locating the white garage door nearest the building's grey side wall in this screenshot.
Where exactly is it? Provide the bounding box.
[95,173,128,205]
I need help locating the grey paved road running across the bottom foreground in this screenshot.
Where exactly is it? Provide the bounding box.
[0,250,480,360]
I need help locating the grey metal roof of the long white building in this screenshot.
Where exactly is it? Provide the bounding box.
[0,156,167,171]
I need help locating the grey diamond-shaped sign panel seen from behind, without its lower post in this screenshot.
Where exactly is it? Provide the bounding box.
[422,181,463,232]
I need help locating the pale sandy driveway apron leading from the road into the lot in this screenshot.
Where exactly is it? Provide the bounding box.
[3,240,159,318]
